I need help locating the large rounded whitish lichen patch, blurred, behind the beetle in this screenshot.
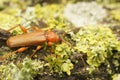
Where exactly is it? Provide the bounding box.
[64,2,107,27]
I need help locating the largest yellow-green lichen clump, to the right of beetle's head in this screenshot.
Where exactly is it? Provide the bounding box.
[72,26,120,68]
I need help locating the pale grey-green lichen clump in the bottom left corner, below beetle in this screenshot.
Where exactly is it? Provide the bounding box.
[0,58,44,80]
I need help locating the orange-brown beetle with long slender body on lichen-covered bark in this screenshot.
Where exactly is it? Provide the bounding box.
[2,25,60,59]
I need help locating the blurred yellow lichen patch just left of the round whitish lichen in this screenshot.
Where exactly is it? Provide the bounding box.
[35,4,63,19]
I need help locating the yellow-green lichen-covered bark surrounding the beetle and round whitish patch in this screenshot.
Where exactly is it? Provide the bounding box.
[0,0,120,80]
